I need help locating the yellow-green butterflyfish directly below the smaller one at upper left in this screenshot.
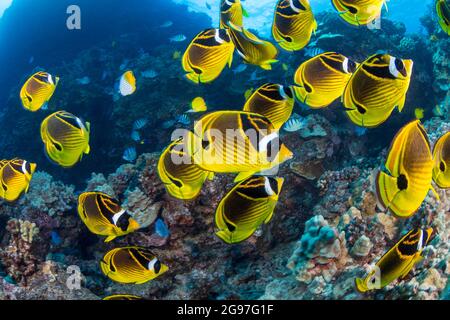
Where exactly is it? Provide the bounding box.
[41,111,90,168]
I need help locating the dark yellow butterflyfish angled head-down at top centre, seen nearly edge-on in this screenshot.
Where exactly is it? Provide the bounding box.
[228,22,278,70]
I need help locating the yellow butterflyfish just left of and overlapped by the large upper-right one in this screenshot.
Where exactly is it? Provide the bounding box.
[293,52,358,109]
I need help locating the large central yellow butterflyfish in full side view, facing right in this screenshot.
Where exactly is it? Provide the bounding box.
[188,111,293,181]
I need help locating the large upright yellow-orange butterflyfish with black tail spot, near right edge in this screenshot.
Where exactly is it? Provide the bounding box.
[376,120,434,218]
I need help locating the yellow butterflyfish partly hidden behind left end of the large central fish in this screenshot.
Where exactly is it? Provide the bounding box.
[158,132,214,200]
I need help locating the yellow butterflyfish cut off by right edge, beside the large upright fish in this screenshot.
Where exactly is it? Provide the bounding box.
[433,132,450,189]
